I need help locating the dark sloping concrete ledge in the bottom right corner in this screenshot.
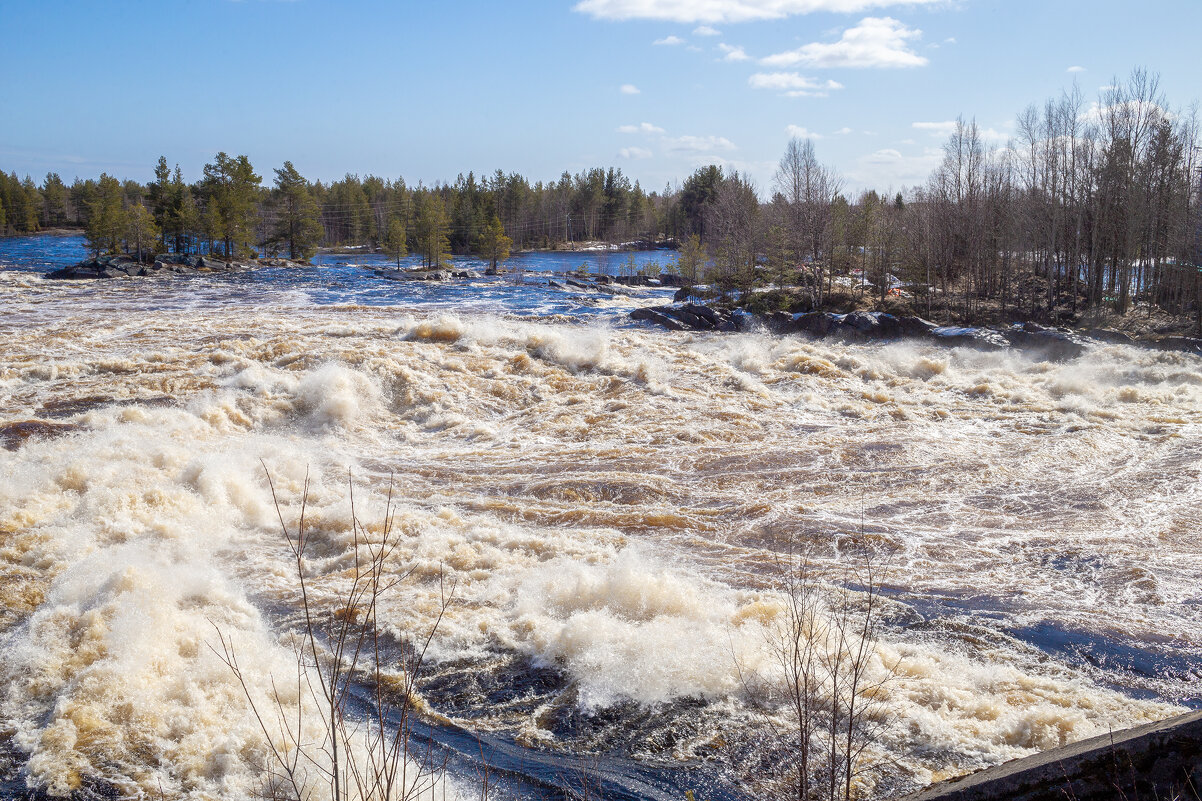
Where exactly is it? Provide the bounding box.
[905,712,1202,801]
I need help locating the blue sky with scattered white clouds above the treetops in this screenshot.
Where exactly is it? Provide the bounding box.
[0,0,1202,196]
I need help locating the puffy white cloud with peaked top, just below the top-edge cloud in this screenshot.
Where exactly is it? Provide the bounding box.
[760,17,927,69]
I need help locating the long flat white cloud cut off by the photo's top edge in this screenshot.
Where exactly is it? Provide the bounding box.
[573,0,944,23]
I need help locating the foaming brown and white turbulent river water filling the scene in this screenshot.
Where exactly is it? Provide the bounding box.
[0,238,1202,799]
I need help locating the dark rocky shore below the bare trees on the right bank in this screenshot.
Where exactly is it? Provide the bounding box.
[630,303,1202,361]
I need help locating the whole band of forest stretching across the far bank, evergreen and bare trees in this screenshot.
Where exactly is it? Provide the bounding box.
[0,69,1202,325]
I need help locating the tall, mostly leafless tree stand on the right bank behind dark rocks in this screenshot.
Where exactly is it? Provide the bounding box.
[679,70,1202,327]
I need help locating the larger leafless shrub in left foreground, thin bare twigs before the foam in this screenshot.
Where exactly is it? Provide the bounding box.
[213,464,454,801]
